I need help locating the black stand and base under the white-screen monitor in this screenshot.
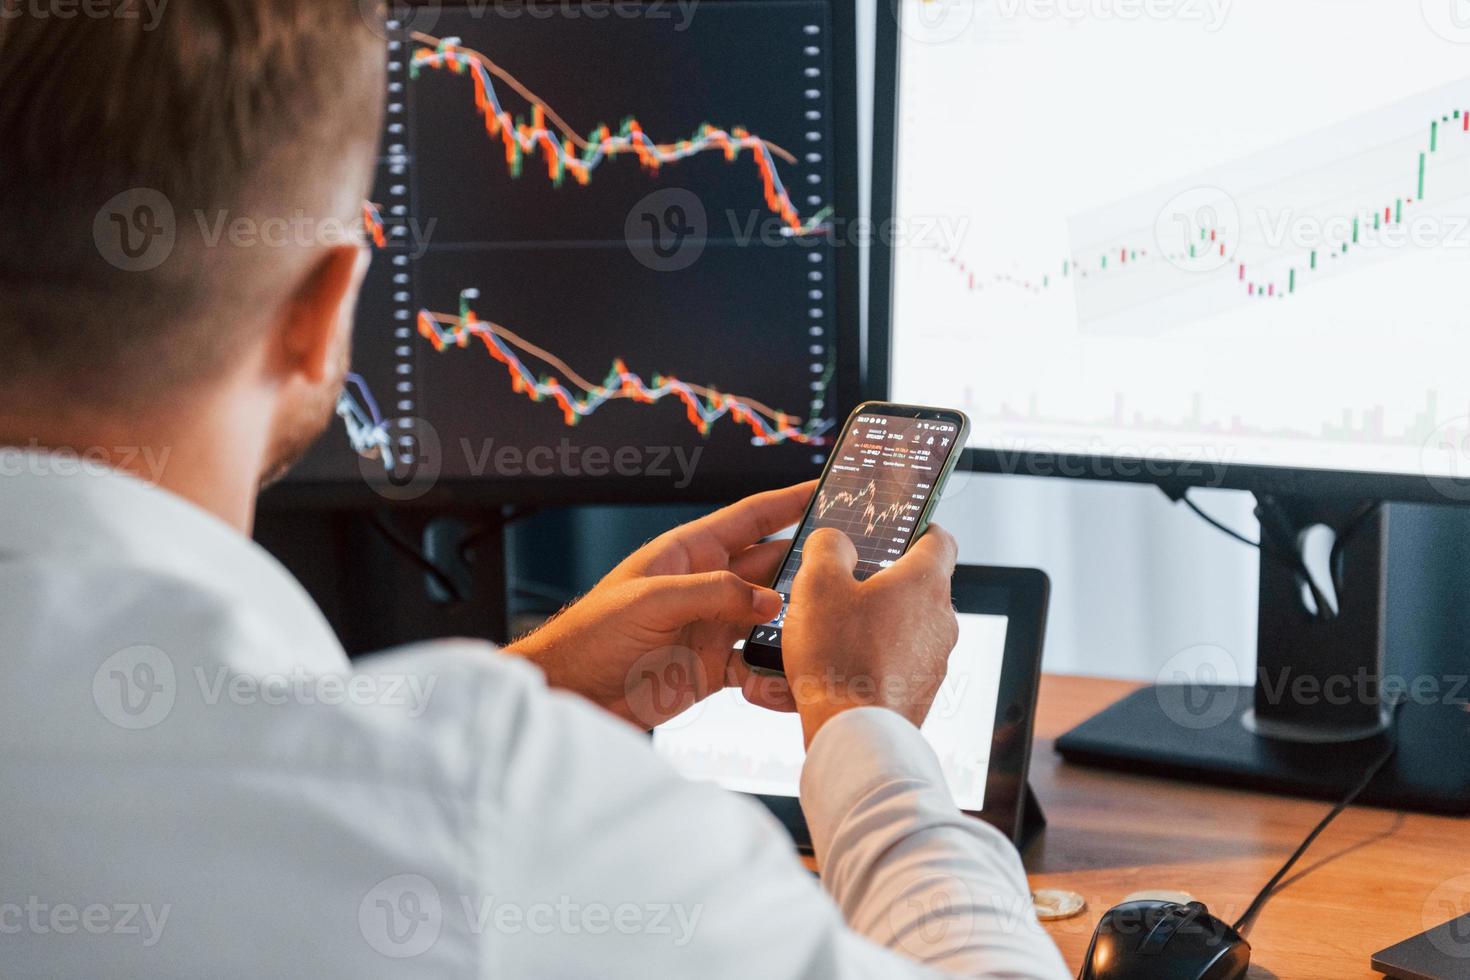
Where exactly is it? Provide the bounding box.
[1057,497,1470,814]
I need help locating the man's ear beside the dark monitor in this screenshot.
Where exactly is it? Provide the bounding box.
[278,244,372,385]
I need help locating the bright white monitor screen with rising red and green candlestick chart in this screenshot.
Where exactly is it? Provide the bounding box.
[891,0,1470,487]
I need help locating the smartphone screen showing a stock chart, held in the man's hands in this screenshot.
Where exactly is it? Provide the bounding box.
[753,414,958,644]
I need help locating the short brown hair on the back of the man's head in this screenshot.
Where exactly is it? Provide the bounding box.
[0,0,387,410]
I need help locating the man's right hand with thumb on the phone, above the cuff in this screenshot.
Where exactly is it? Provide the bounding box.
[781,526,958,745]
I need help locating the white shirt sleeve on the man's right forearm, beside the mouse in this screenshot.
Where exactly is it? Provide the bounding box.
[801,708,1070,979]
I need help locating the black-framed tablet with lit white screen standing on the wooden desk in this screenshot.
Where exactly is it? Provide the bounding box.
[653,566,1048,848]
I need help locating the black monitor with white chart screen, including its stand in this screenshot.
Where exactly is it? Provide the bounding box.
[872,0,1470,810]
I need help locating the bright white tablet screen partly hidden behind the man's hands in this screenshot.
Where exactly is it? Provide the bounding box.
[653,613,1008,813]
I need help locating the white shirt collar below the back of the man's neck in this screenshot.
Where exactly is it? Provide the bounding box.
[0,448,347,669]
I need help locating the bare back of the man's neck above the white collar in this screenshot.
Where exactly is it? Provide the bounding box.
[0,390,268,535]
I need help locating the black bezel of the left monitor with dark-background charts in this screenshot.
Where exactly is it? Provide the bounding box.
[260,0,872,511]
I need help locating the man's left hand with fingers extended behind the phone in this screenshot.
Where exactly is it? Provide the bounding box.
[507,482,816,727]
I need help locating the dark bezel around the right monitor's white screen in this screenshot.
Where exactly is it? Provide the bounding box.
[867,0,1470,504]
